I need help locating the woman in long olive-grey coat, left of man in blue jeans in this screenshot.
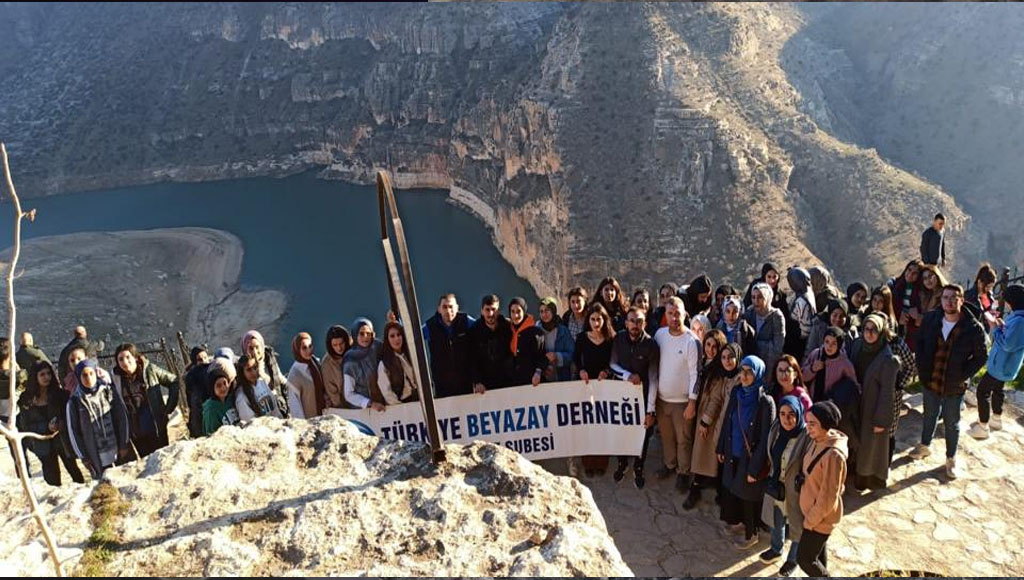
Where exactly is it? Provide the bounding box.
[850,315,899,489]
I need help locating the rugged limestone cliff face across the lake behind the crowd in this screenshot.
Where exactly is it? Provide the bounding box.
[0,3,980,295]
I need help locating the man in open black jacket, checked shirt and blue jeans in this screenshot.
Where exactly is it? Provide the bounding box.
[910,284,987,480]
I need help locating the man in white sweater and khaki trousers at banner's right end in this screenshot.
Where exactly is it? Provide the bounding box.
[654,296,700,493]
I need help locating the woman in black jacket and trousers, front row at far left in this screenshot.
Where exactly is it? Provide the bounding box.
[17,359,85,486]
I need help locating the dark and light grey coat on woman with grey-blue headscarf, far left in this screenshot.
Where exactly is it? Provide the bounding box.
[66,382,130,480]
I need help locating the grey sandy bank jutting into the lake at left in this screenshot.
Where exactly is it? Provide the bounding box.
[0,227,287,360]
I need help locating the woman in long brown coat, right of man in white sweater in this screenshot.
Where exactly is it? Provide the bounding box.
[683,343,742,509]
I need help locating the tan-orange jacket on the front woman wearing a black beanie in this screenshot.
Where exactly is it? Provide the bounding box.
[800,429,848,535]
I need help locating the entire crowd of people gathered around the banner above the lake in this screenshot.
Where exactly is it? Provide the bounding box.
[0,216,1024,576]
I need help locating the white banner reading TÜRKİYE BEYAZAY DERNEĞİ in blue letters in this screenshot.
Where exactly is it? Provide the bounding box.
[326,379,646,459]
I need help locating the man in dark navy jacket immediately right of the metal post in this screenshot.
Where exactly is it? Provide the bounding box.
[423,294,473,399]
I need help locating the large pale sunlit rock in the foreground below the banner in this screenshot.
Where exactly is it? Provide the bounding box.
[0,417,632,577]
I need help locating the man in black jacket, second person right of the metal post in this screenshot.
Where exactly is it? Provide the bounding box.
[469,294,513,392]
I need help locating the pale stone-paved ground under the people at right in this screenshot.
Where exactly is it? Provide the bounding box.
[542,393,1024,577]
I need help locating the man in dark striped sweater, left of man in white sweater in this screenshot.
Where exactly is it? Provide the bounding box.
[611,306,659,489]
